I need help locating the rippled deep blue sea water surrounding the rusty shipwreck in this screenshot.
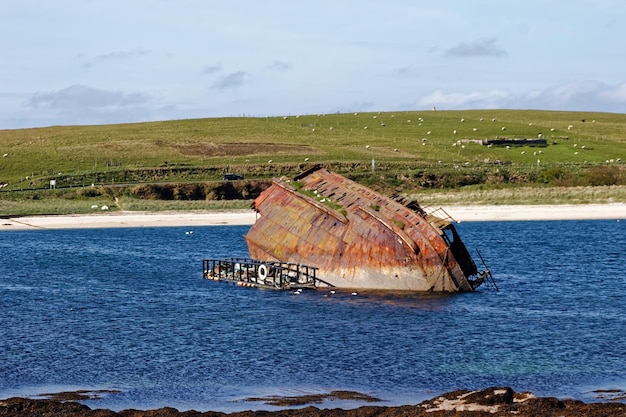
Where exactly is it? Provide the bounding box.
[0,221,626,411]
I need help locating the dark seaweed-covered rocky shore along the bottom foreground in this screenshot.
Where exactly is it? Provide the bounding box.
[0,387,626,417]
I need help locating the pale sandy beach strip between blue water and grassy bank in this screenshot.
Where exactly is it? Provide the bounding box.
[0,203,626,231]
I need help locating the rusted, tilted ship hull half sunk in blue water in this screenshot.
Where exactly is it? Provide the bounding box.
[246,167,484,292]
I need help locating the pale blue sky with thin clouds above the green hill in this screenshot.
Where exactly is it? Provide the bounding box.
[0,0,626,129]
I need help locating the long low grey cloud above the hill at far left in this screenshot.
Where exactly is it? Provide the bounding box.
[26,84,151,109]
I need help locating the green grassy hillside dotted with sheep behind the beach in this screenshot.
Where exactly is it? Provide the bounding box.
[0,110,626,215]
